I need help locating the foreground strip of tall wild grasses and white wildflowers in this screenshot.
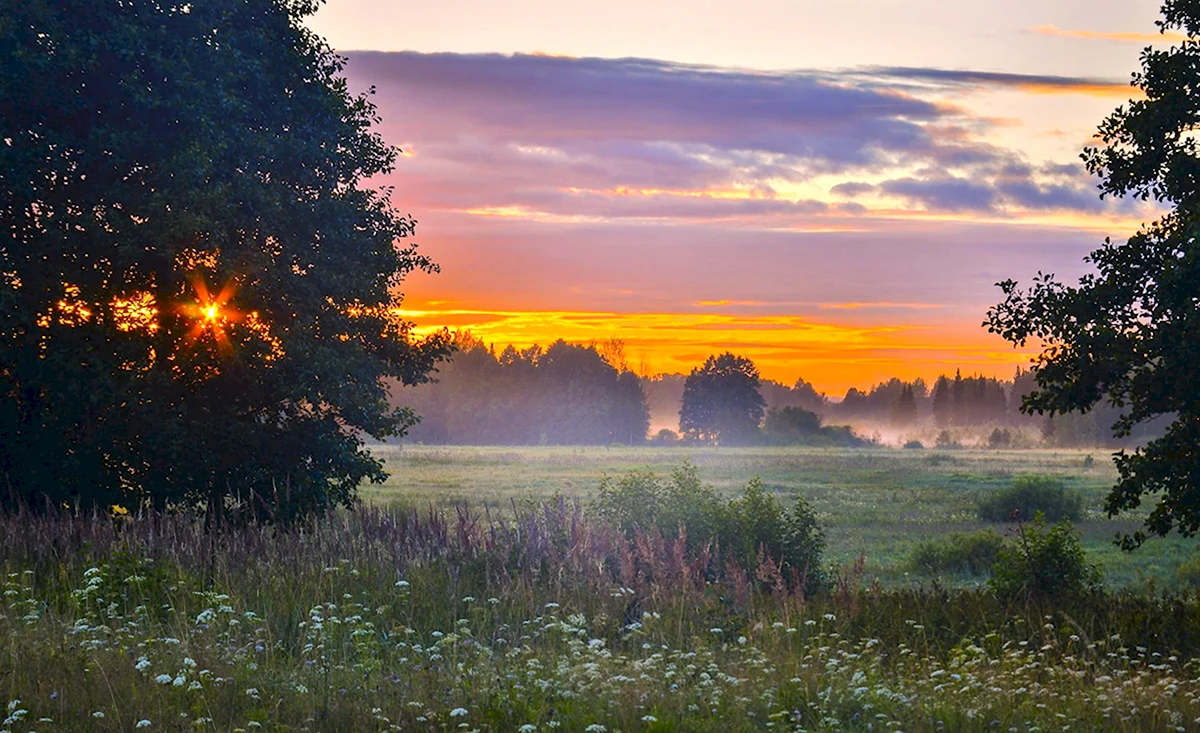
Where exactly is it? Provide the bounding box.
[0,503,1200,733]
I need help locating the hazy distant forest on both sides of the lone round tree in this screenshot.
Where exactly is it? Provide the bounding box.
[394,334,1165,447]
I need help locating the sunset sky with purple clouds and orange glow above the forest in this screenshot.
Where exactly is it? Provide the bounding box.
[310,0,1172,396]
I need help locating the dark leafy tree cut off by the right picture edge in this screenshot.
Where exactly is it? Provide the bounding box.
[985,0,1200,548]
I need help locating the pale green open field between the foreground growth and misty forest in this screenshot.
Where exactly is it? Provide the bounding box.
[361,445,1200,589]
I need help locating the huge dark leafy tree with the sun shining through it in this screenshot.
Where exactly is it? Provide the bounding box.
[0,0,448,521]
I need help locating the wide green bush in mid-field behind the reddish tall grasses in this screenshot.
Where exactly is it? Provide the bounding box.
[595,462,824,591]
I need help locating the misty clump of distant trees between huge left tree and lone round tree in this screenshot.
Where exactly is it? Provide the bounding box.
[397,334,650,445]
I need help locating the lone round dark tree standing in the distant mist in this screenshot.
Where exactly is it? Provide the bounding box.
[679,352,764,445]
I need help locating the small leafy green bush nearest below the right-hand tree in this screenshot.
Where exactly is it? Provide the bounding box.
[989,512,1100,600]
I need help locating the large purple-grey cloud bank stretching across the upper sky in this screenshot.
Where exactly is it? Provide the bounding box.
[347,52,1152,230]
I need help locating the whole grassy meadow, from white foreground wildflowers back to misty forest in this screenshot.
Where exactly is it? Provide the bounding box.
[7,446,1200,733]
